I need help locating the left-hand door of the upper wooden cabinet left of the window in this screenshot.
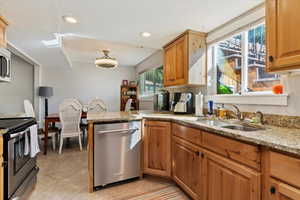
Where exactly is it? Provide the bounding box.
[164,45,176,86]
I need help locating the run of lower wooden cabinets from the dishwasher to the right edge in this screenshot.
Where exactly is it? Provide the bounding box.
[143,120,300,200]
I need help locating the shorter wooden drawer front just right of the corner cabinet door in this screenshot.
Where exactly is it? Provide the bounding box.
[172,123,202,145]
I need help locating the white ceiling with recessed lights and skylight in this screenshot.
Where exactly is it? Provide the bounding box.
[0,0,263,67]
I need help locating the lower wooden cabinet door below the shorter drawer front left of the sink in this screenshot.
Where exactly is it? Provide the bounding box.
[172,136,202,199]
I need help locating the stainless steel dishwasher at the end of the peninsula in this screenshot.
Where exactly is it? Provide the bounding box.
[94,121,141,187]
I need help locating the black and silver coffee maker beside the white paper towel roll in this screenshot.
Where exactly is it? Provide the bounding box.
[170,92,195,114]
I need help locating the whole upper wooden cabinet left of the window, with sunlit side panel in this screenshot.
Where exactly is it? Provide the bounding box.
[164,30,206,86]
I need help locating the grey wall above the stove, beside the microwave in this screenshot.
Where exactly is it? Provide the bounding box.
[0,54,34,115]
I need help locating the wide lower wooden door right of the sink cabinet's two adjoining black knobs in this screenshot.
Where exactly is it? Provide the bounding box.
[203,153,261,200]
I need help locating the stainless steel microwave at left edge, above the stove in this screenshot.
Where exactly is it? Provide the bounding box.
[0,48,11,82]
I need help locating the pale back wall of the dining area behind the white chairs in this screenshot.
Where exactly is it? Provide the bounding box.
[42,63,135,113]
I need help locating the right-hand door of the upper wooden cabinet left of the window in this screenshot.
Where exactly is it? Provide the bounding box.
[174,35,188,85]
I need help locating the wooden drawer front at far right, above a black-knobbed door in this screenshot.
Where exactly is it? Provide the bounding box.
[270,152,300,187]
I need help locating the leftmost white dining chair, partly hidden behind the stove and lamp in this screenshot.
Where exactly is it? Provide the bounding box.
[24,99,58,151]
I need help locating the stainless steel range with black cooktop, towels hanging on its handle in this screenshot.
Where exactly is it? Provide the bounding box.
[0,118,38,200]
